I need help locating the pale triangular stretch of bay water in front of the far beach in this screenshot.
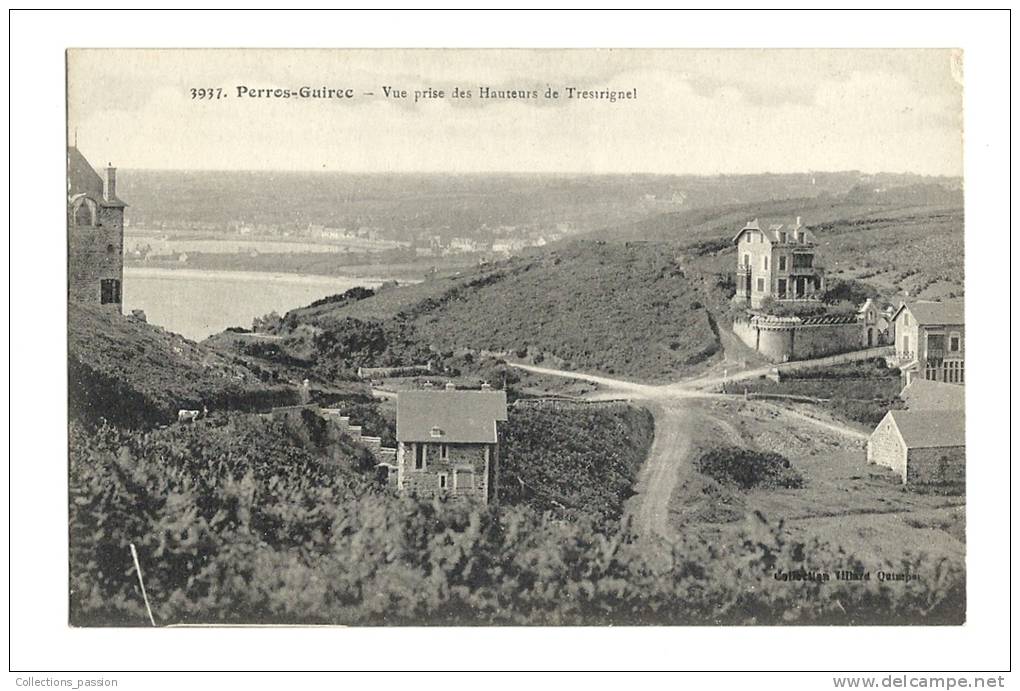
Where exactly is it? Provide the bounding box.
[123,268,380,341]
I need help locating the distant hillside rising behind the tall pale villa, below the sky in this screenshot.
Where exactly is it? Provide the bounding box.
[592,184,964,299]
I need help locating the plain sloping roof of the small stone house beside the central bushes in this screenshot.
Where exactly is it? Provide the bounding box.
[397,390,507,444]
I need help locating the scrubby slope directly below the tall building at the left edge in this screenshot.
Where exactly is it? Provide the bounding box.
[67,303,297,427]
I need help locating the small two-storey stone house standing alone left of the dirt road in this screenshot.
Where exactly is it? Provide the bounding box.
[397,385,507,503]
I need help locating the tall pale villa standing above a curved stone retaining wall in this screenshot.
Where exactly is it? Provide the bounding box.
[732,216,825,308]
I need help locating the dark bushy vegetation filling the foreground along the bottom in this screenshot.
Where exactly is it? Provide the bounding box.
[69,406,965,626]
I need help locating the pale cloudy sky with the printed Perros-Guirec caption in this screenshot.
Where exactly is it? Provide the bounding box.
[67,49,963,176]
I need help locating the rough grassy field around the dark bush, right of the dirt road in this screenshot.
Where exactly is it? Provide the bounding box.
[670,401,965,567]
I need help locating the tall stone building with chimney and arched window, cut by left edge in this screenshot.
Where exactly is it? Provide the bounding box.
[67,146,128,311]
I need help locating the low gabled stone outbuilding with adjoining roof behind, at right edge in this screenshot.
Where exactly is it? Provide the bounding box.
[867,379,967,489]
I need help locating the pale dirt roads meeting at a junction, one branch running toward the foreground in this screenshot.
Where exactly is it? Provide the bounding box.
[508,351,867,537]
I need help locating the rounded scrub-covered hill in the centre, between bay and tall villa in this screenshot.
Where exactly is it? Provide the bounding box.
[225,242,720,381]
